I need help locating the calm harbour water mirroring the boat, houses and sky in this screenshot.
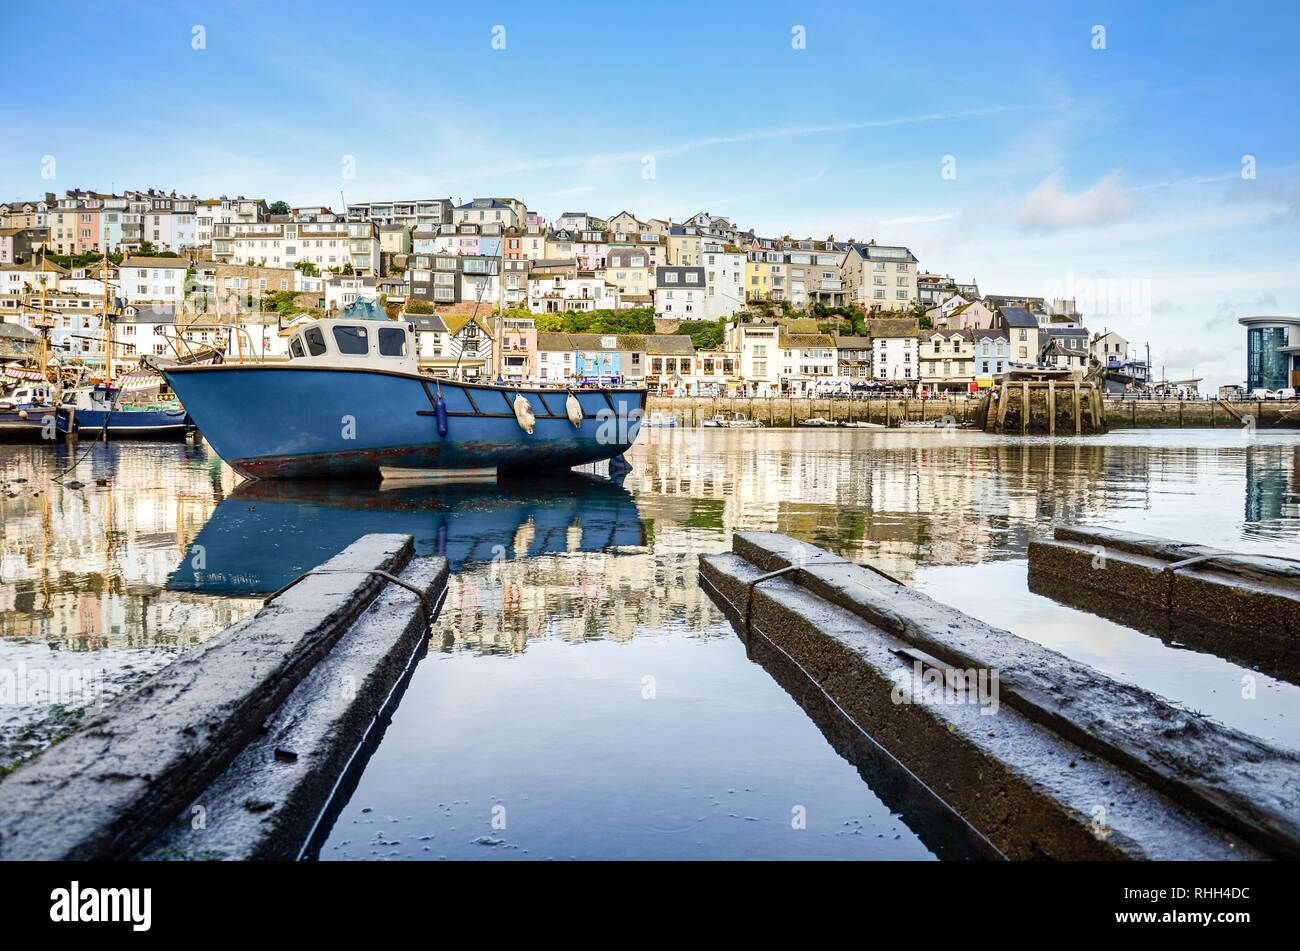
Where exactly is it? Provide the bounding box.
[0,429,1300,859]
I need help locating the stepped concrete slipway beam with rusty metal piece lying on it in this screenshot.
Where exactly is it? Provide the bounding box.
[699,533,1300,860]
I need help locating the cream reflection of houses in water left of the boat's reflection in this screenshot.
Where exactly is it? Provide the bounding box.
[0,443,257,650]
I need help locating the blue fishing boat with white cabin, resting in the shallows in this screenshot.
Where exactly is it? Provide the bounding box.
[159,318,646,478]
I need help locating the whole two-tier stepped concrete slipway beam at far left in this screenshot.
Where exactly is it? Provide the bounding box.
[0,534,447,860]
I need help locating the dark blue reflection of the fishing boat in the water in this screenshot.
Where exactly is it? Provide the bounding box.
[166,473,645,594]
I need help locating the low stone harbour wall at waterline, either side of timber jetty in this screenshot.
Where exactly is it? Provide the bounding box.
[646,395,1300,430]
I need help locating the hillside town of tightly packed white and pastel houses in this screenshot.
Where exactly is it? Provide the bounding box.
[0,188,1159,396]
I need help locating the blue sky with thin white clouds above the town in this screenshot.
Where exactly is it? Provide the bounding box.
[0,0,1300,385]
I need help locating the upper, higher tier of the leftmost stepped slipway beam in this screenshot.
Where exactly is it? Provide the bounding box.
[0,534,413,860]
